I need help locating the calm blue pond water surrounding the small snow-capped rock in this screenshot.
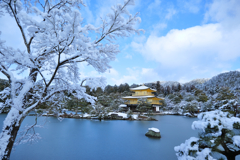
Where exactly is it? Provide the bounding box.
[0,114,201,160]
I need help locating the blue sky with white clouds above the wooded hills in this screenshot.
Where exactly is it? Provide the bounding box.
[0,0,240,85]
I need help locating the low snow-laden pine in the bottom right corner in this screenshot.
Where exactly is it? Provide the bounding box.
[174,110,240,160]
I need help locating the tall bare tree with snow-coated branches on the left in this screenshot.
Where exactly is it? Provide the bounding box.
[0,0,141,159]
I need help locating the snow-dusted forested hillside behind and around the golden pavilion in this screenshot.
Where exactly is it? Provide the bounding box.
[0,71,240,116]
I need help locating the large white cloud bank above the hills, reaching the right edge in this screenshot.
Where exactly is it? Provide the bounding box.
[132,0,240,82]
